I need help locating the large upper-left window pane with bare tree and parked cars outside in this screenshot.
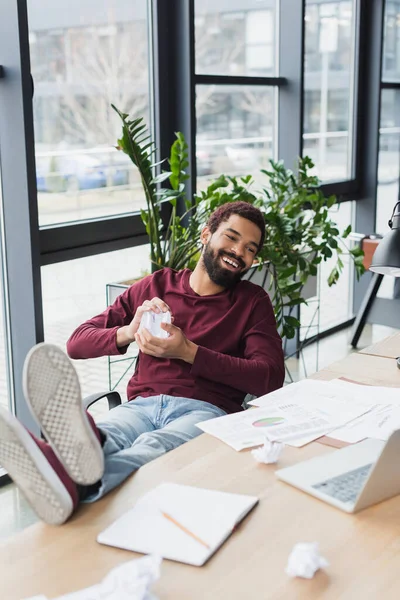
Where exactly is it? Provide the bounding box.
[28,0,149,225]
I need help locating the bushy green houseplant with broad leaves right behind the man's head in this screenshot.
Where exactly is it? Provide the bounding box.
[196,156,365,339]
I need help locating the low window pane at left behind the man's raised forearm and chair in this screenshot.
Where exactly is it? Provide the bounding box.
[41,245,150,416]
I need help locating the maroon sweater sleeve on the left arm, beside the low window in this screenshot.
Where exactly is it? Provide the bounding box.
[67,282,143,358]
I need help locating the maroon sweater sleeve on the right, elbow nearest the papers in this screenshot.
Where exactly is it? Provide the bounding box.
[191,292,285,396]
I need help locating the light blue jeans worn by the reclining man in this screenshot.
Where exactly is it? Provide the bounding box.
[84,394,226,502]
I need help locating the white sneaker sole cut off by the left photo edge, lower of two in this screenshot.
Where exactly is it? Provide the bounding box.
[0,408,73,525]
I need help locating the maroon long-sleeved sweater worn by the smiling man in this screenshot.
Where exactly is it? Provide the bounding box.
[67,269,284,413]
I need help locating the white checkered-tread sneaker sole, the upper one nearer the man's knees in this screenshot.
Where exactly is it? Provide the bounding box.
[23,343,104,485]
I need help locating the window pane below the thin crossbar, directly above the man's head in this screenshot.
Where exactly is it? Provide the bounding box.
[196,85,276,188]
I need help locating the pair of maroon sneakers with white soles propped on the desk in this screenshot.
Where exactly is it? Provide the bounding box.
[0,344,104,524]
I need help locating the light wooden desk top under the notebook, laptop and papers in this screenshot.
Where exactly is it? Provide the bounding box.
[0,355,400,600]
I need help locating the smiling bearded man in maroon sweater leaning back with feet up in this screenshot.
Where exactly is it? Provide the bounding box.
[0,202,284,523]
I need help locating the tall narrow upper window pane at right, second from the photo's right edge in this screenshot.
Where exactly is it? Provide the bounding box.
[303,0,356,181]
